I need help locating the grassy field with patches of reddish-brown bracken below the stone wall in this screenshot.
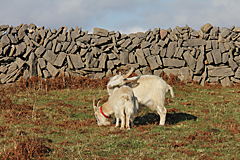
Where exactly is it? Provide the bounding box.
[0,75,240,159]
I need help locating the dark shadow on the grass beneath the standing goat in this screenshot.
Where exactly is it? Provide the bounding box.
[134,113,197,126]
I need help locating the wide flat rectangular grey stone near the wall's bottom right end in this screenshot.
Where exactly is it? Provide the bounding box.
[208,66,234,77]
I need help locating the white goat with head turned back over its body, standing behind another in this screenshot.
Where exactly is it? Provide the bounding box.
[107,68,174,125]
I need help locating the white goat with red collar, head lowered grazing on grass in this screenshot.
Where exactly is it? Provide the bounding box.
[93,86,138,129]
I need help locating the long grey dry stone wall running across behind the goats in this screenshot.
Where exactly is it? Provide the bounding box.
[0,23,240,86]
